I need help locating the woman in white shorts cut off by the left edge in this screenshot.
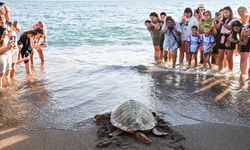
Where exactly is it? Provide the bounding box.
[0,26,15,88]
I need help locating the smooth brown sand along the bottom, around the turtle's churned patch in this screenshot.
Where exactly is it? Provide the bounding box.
[0,123,250,150]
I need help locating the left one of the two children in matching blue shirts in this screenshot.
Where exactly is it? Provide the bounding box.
[188,25,201,67]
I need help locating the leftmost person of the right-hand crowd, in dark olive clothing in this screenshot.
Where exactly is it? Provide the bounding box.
[146,12,162,61]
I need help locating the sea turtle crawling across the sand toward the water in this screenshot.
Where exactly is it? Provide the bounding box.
[95,100,168,144]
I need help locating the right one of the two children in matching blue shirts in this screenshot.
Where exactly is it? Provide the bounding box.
[201,25,216,69]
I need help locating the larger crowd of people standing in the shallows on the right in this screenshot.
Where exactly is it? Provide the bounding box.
[145,4,250,80]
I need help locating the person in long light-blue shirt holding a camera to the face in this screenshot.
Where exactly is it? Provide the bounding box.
[162,16,181,68]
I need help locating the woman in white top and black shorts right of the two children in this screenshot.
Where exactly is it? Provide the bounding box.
[218,6,237,71]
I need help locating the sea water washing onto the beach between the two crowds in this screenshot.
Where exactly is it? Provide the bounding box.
[0,0,250,130]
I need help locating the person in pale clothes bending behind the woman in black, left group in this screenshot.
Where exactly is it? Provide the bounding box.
[30,21,48,64]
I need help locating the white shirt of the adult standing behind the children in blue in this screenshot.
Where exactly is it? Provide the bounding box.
[181,16,199,41]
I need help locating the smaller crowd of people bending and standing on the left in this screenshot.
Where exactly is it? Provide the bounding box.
[0,2,48,88]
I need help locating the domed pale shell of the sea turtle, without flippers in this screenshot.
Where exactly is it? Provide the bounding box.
[110,100,156,131]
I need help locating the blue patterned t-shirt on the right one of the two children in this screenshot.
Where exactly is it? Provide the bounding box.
[201,33,215,53]
